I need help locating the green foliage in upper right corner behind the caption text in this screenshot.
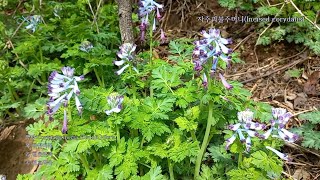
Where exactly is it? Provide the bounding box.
[218,0,320,55]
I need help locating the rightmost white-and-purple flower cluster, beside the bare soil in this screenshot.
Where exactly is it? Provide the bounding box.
[262,108,299,142]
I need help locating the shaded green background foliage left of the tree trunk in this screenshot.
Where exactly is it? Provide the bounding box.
[0,0,120,120]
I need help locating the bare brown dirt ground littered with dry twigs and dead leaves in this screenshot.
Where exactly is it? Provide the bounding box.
[0,0,320,180]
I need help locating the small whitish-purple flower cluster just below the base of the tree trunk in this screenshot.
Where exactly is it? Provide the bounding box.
[113,43,138,75]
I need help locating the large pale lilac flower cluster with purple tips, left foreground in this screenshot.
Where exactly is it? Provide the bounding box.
[47,67,84,119]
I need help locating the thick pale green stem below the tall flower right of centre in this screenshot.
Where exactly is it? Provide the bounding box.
[194,101,213,179]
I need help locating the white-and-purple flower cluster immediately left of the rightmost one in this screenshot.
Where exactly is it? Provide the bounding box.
[226,109,266,152]
